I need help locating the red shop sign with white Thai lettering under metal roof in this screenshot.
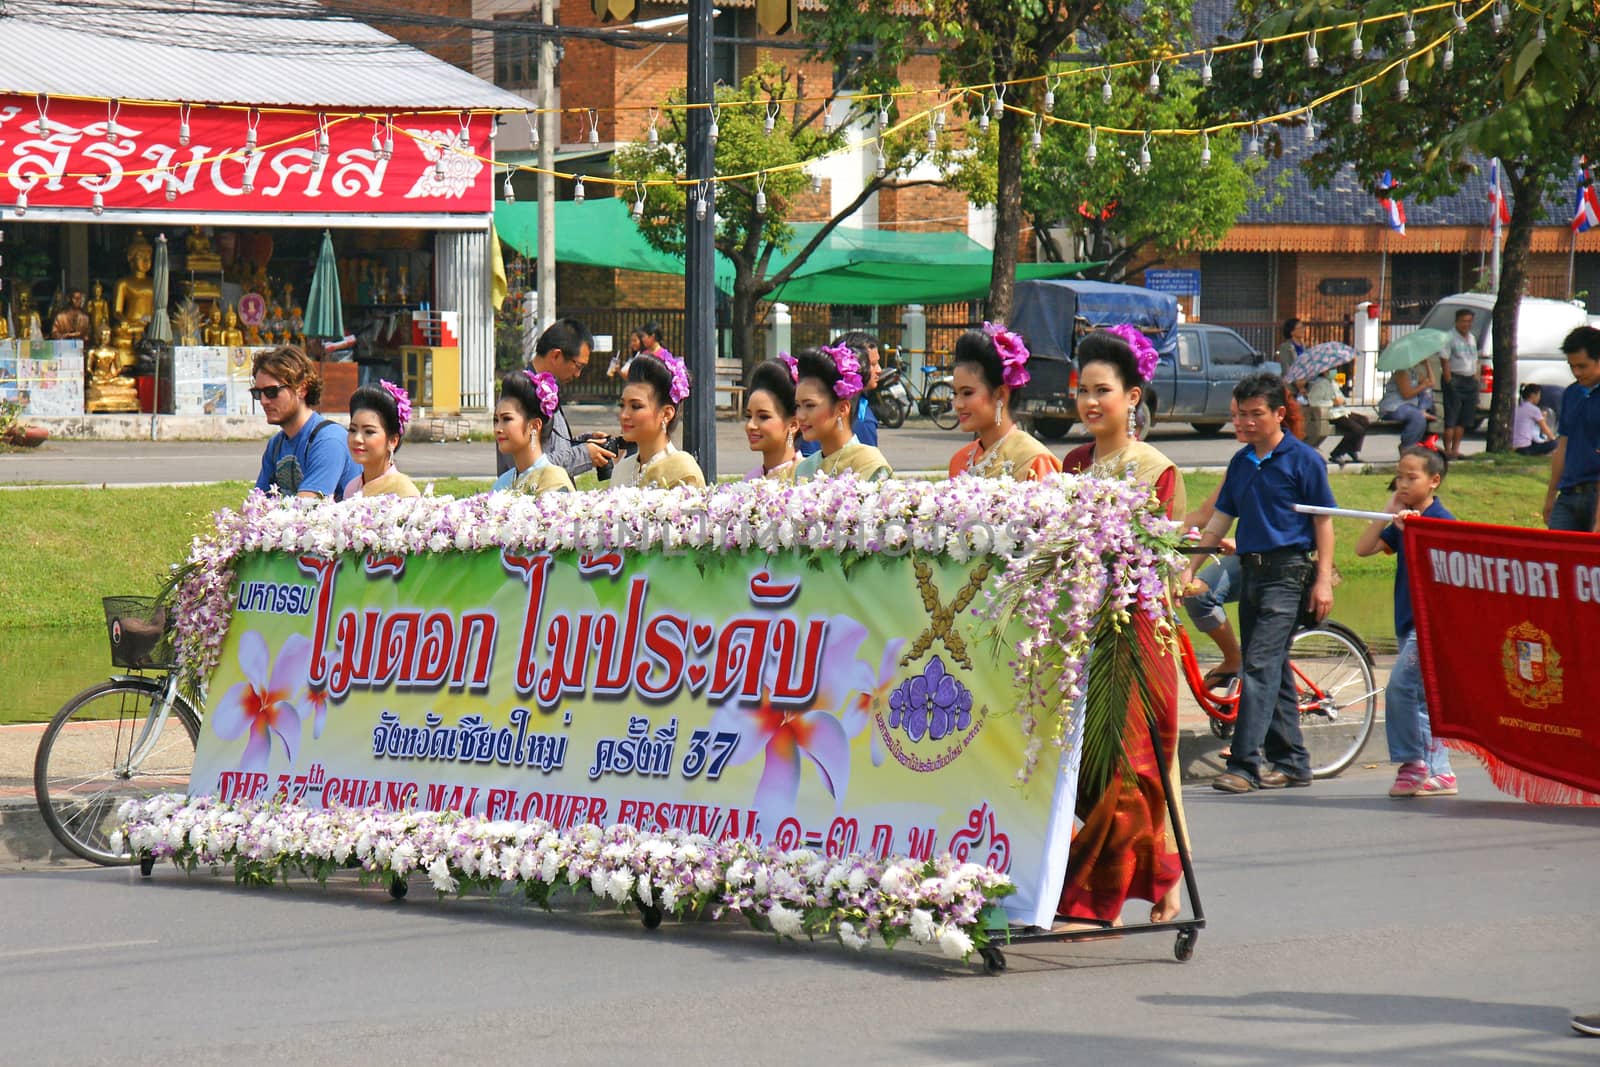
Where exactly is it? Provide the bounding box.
[0,94,494,214]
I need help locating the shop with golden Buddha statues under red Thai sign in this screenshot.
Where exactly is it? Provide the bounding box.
[0,10,517,416]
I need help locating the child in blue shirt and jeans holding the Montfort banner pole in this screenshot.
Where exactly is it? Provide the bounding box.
[1355,445,1456,797]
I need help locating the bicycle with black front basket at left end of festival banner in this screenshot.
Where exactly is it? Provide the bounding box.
[34,597,200,865]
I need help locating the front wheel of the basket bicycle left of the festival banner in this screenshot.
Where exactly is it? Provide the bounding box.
[34,678,200,865]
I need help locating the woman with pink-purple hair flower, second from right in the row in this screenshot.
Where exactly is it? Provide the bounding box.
[950,323,1061,482]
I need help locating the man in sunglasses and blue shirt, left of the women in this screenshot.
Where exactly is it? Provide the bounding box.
[250,344,362,501]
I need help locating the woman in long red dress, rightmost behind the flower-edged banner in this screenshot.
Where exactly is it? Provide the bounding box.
[1056,326,1187,929]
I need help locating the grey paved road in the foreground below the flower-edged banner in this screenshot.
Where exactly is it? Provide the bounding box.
[0,771,1600,1067]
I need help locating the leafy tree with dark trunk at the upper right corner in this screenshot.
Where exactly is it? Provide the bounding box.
[1208,0,1600,451]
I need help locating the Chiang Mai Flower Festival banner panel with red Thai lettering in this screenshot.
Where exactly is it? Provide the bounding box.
[190,550,1077,925]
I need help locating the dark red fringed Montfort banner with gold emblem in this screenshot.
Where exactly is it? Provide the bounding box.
[1405,518,1600,803]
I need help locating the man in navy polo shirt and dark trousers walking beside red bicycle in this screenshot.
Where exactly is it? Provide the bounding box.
[1200,374,1334,793]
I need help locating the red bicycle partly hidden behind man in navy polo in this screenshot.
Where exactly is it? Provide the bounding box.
[1178,619,1382,777]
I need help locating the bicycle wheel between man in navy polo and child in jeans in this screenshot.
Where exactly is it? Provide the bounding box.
[1290,622,1381,777]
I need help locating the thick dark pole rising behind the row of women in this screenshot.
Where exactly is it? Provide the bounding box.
[678,0,717,485]
